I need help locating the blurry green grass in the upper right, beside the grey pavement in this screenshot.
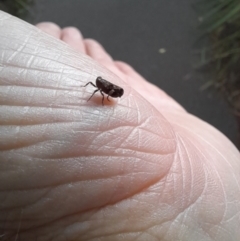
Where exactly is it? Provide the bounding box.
[194,0,240,114]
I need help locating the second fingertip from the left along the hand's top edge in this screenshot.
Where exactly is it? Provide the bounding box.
[61,27,86,53]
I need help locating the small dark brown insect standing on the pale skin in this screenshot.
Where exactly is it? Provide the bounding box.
[82,76,124,105]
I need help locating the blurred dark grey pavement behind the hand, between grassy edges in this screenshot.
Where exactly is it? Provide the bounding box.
[1,0,238,144]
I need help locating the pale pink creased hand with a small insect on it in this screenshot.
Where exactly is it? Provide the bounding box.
[0,12,240,241]
